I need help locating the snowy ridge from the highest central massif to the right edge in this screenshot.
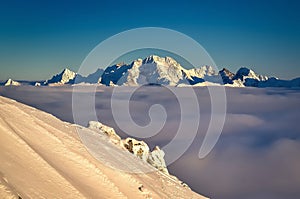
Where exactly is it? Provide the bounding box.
[82,55,300,87]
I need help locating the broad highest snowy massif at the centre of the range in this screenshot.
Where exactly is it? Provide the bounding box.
[101,55,186,86]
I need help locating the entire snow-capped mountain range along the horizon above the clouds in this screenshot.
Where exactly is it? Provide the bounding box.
[3,55,300,87]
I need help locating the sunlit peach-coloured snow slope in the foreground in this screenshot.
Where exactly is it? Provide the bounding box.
[0,97,205,198]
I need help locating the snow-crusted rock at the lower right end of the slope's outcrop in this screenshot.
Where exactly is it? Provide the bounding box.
[147,146,169,174]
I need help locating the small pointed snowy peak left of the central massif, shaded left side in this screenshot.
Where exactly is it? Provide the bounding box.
[44,68,76,85]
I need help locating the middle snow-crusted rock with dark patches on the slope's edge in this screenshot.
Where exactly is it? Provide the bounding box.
[122,138,149,162]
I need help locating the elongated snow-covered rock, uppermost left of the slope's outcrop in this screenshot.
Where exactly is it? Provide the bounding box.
[88,121,121,144]
